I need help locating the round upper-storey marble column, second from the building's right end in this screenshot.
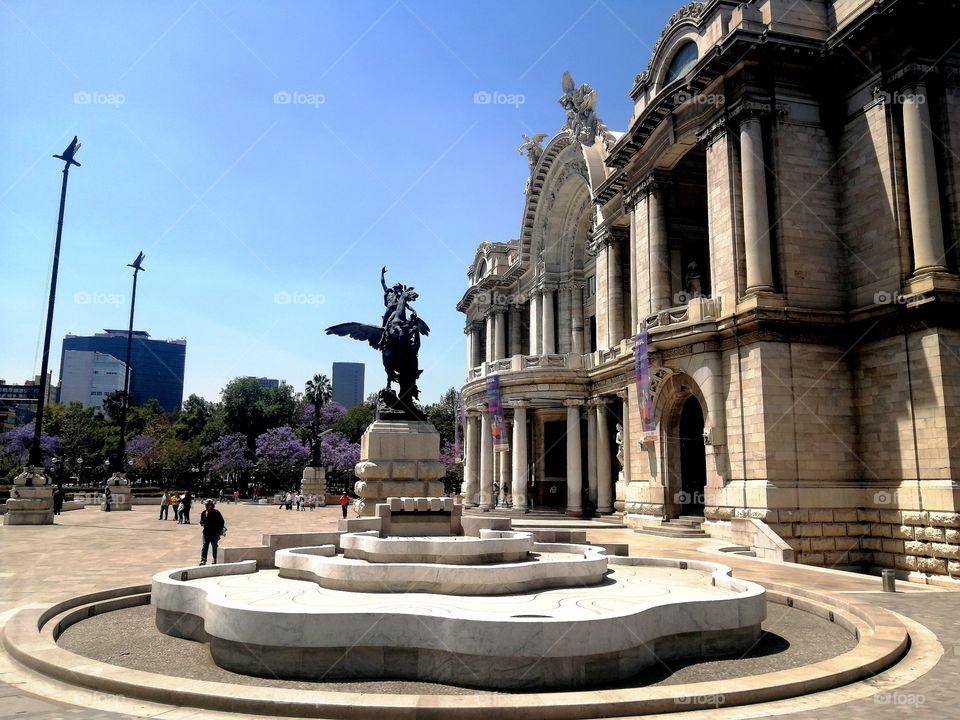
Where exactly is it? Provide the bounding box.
[740,116,773,293]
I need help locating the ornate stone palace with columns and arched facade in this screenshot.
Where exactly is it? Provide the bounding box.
[457,0,960,581]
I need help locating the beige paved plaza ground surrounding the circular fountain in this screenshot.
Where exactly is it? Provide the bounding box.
[0,503,960,720]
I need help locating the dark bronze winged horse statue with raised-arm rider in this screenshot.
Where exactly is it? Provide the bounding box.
[326,267,430,420]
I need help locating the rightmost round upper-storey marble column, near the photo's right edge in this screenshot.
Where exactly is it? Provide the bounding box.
[902,83,946,274]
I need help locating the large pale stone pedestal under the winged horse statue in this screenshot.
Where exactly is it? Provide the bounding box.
[354,420,445,517]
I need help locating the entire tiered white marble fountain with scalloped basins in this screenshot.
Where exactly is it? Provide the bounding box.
[152,498,766,689]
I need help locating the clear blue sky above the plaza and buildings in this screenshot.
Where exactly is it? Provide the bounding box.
[0,0,682,403]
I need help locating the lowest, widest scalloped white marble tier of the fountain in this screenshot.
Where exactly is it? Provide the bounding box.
[152,556,766,689]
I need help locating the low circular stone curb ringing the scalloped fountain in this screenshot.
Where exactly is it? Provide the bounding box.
[2,561,909,720]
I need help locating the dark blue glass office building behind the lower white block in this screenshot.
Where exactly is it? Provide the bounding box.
[60,330,187,412]
